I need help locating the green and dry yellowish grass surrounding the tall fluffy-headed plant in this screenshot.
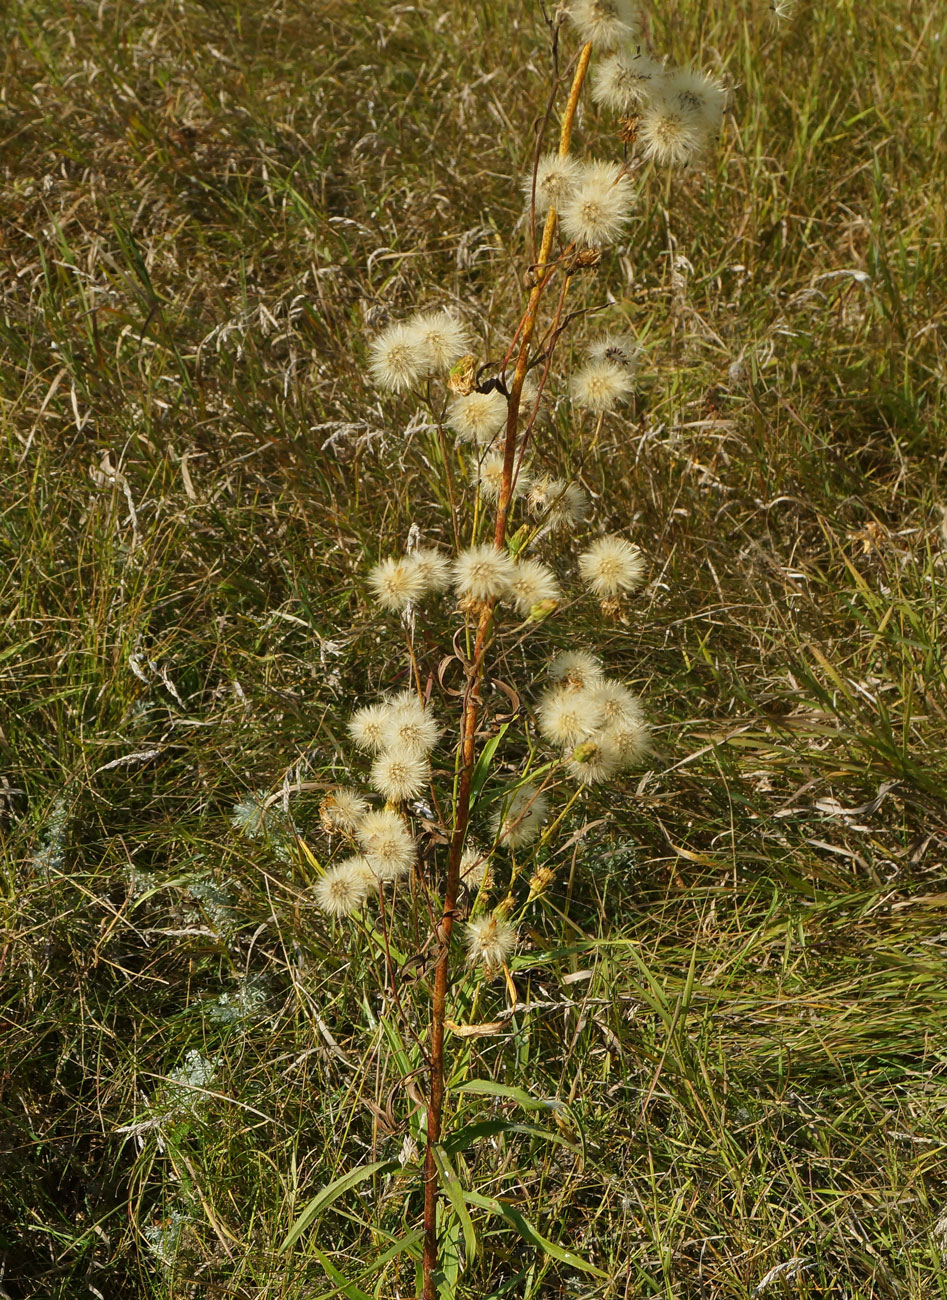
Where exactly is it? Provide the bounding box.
[0,0,947,1300]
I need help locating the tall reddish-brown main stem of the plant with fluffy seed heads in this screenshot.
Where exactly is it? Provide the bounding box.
[423,44,592,1300]
